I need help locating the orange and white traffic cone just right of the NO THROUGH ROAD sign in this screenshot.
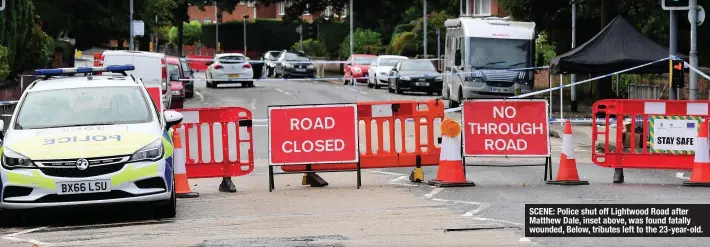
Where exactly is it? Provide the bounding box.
[547,119,589,185]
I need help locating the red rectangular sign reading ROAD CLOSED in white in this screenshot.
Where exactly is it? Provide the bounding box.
[269,104,360,165]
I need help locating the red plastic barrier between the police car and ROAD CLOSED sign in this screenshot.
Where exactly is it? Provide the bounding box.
[173,107,254,178]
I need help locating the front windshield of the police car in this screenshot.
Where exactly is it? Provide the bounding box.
[14,87,153,130]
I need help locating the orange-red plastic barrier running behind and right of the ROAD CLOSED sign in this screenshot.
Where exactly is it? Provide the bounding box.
[281,99,444,172]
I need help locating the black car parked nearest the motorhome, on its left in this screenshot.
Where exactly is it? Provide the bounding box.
[387,60,443,95]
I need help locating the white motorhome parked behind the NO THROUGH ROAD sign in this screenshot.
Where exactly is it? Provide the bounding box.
[442,16,537,107]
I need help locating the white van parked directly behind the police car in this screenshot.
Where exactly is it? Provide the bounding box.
[101,50,172,110]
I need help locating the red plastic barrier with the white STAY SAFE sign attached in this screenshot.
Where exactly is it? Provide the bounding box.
[592,99,710,169]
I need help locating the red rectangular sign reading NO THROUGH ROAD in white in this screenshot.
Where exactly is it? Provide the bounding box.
[462,100,550,157]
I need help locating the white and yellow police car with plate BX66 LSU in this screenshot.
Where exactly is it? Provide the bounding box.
[0,65,182,218]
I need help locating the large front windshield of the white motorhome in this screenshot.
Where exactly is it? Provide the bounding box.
[469,38,531,69]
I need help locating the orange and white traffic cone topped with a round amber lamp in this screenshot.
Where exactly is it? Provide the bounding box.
[429,119,476,187]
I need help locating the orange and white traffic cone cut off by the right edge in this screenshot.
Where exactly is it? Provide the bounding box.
[683,120,710,187]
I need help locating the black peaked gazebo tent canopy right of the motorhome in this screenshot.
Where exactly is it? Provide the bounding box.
[550,16,669,74]
